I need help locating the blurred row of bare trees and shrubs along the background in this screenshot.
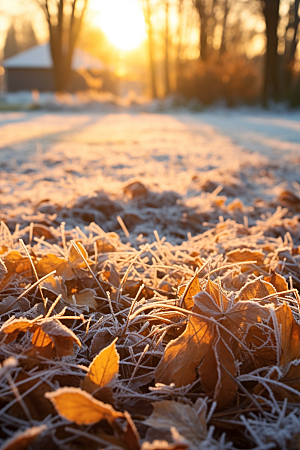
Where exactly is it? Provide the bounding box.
[4,0,300,105]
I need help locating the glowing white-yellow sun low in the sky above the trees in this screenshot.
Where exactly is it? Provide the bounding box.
[92,0,146,51]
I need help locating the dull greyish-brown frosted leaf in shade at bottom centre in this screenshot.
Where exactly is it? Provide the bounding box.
[145,400,207,449]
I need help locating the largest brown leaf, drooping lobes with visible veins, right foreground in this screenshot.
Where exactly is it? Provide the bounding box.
[155,280,270,409]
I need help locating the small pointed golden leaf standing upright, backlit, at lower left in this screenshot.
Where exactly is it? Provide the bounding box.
[81,338,120,393]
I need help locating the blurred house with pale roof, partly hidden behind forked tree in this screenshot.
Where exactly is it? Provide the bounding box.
[3,43,118,94]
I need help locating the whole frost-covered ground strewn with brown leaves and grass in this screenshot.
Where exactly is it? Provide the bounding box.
[0,107,300,450]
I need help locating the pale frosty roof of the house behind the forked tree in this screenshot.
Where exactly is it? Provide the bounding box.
[3,42,105,70]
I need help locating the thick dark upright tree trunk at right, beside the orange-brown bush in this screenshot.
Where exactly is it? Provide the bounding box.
[263,0,280,106]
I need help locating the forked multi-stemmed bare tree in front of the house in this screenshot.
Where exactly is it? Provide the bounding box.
[39,0,88,91]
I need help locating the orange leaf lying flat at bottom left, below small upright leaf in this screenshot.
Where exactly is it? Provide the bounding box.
[45,388,123,425]
